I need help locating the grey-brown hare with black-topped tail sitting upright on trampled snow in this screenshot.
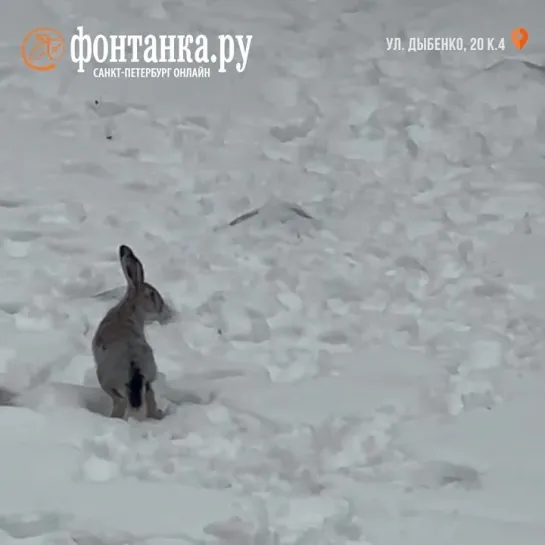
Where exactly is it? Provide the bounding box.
[92,245,173,420]
